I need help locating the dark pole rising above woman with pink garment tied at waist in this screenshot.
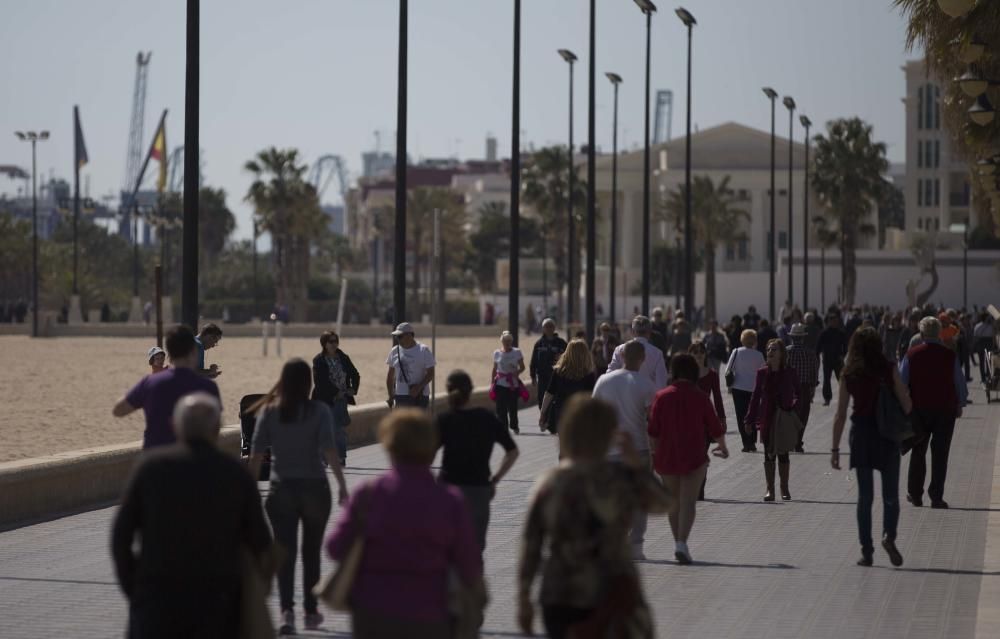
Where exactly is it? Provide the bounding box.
[508,0,531,346]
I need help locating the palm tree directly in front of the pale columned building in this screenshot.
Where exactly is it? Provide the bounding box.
[657,175,750,319]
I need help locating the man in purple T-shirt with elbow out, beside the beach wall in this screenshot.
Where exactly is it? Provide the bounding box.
[111,326,219,448]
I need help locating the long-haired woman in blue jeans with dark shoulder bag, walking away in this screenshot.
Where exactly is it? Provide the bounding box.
[830,328,913,566]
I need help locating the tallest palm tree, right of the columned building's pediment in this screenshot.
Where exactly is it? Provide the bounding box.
[812,118,889,304]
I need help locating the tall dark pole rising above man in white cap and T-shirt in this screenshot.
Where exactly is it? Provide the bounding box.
[392,0,408,324]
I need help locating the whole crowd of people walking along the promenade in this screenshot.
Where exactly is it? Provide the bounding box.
[112,305,984,638]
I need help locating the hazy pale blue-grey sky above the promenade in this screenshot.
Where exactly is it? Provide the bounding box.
[0,0,920,238]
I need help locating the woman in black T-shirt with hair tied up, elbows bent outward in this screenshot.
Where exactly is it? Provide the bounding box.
[437,371,518,552]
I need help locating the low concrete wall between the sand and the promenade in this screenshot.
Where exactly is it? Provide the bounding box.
[0,389,530,529]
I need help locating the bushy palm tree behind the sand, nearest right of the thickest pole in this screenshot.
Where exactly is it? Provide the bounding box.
[243,147,326,321]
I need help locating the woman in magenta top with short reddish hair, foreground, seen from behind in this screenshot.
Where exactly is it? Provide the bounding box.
[326,408,482,639]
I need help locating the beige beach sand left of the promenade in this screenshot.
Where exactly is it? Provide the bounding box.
[0,336,516,462]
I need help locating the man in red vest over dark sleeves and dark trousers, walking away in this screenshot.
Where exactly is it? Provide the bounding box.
[899,317,969,508]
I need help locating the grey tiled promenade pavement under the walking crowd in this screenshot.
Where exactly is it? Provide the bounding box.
[0,387,1000,639]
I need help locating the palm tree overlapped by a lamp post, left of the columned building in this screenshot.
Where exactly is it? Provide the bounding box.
[521,146,587,310]
